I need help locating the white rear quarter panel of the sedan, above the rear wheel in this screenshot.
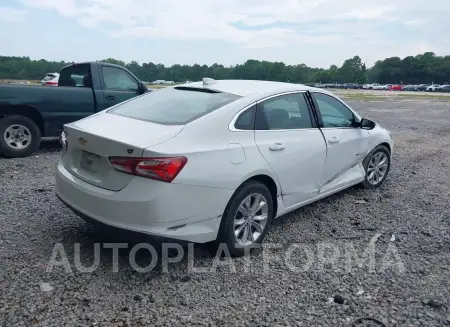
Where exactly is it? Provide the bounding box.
[144,102,279,193]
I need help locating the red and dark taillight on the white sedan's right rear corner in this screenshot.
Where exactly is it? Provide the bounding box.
[109,157,187,183]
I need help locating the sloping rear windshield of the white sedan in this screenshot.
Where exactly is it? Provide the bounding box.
[108,88,240,125]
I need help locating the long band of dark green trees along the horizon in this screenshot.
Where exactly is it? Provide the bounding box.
[0,52,450,84]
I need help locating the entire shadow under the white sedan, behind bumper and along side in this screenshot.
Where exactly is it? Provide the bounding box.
[52,187,358,278]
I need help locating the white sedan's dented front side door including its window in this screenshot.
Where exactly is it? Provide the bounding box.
[311,92,369,186]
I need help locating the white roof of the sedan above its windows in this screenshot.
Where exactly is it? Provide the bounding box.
[175,78,323,97]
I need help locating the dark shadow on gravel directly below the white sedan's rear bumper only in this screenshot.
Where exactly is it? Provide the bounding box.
[53,217,221,278]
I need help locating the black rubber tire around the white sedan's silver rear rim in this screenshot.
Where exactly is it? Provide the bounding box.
[217,181,274,256]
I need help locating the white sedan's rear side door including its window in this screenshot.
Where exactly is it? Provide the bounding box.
[255,92,326,207]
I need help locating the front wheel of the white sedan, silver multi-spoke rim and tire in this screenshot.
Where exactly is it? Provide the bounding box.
[361,145,391,189]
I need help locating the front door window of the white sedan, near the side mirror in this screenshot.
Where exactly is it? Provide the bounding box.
[313,93,355,127]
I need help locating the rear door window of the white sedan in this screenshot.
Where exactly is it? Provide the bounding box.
[256,93,312,130]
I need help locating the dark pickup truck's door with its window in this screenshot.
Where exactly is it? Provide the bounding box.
[100,66,139,109]
